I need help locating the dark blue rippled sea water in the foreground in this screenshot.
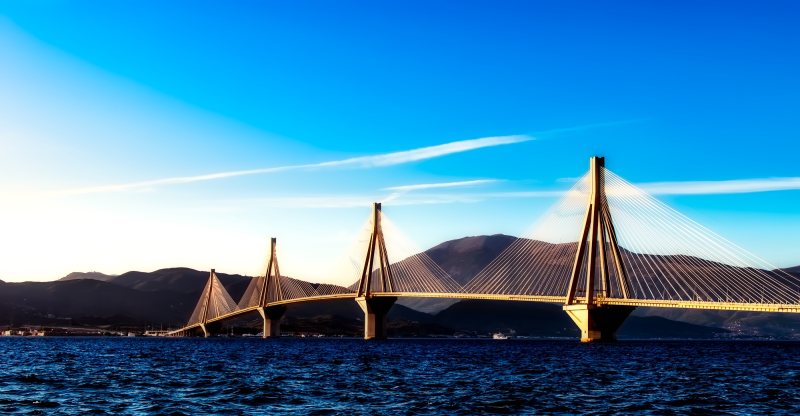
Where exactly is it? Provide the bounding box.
[0,337,800,415]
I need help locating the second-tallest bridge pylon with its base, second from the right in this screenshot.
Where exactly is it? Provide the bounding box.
[356,202,397,339]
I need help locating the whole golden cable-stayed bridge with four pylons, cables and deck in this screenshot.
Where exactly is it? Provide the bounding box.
[170,157,800,341]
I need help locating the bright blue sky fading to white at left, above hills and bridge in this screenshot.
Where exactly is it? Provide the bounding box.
[0,0,800,283]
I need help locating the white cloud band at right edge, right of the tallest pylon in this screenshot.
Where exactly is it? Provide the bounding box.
[636,177,800,195]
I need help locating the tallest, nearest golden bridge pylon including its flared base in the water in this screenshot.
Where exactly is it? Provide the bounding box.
[564,157,634,342]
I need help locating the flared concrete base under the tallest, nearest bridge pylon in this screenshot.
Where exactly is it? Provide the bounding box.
[564,304,636,342]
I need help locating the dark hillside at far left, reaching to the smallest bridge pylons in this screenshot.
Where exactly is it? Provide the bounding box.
[0,268,250,326]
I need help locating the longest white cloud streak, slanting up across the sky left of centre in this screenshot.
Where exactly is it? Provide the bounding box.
[52,135,534,195]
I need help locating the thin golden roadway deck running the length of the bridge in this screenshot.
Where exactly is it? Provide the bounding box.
[167,292,800,336]
